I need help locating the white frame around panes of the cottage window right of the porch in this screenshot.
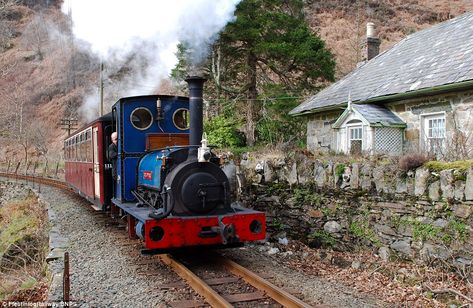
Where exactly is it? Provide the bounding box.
[421,111,447,155]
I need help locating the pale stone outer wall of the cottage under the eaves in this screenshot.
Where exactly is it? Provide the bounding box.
[307,91,473,158]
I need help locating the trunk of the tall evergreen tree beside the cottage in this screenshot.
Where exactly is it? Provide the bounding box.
[245,51,258,146]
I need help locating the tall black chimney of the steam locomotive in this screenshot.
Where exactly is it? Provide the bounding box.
[186,76,206,158]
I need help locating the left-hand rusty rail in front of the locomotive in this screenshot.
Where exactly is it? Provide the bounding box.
[158,254,233,307]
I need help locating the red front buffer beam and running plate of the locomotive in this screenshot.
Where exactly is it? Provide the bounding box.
[113,200,266,250]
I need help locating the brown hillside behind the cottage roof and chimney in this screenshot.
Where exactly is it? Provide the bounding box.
[306,0,473,78]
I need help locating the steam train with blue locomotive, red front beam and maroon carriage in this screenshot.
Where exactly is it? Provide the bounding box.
[64,77,266,253]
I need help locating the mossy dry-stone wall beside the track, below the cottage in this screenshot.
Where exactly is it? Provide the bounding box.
[230,153,473,266]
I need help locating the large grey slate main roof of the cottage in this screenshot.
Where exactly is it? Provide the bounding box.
[289,12,473,115]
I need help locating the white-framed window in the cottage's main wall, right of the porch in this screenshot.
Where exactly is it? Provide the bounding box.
[424,113,446,155]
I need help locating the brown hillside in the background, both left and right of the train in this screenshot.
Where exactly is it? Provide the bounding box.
[0,0,473,160]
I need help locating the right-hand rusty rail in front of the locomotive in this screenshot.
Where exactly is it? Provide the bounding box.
[215,255,312,308]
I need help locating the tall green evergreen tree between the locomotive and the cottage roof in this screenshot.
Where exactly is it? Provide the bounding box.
[211,0,335,145]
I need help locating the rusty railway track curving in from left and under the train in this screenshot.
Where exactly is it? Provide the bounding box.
[0,172,312,307]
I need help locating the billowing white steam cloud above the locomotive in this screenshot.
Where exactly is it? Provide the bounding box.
[62,0,240,120]
